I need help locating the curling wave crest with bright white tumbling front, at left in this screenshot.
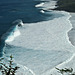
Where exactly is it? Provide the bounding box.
[1,20,23,43]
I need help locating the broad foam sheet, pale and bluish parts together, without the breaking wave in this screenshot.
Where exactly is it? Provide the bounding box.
[2,11,75,75]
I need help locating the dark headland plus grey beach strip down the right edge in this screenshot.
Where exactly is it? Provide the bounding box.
[49,0,75,46]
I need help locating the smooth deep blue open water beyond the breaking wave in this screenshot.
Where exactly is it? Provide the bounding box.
[0,0,51,55]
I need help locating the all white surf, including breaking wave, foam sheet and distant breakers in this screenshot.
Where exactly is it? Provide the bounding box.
[1,1,75,75]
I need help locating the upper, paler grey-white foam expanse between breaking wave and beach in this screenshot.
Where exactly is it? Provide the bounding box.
[5,11,73,51]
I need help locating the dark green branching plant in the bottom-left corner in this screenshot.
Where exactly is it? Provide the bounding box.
[0,55,19,75]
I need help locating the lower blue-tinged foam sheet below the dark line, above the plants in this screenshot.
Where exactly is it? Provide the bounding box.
[5,47,72,75]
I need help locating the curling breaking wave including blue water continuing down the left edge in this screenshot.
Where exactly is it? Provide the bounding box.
[0,19,23,57]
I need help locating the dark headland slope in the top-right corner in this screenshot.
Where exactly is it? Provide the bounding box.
[54,0,75,12]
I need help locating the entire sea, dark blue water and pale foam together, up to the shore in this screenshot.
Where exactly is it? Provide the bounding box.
[0,0,75,75]
